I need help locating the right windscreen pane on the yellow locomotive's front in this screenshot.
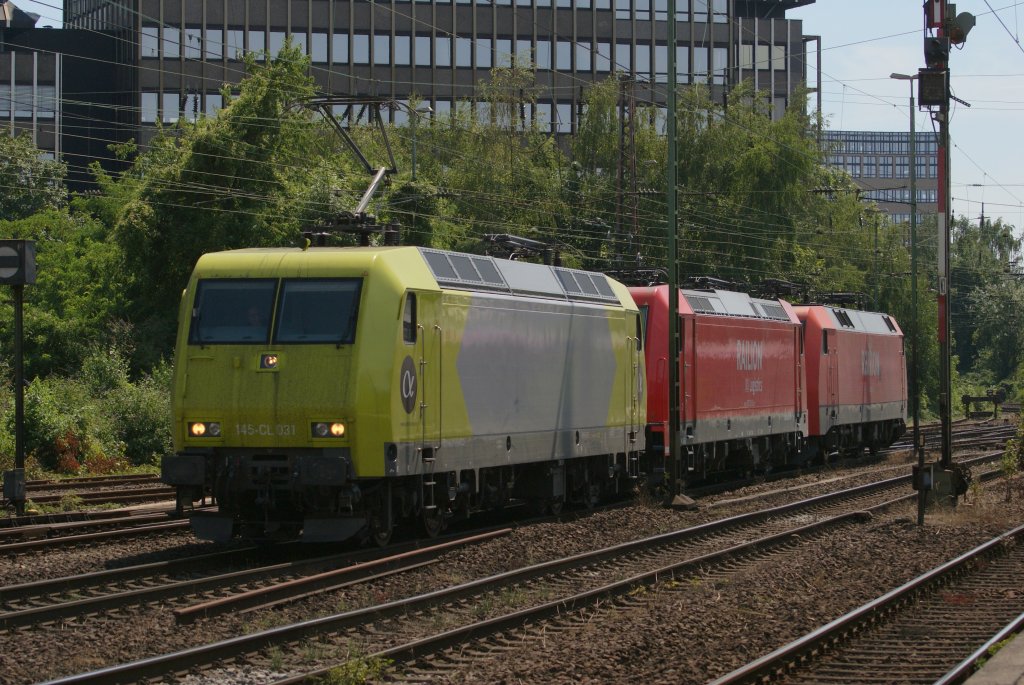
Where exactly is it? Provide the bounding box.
[273,279,362,345]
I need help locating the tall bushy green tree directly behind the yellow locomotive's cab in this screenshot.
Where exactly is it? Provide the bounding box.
[108,43,333,361]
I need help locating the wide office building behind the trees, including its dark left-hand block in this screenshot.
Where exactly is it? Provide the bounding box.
[0,0,814,181]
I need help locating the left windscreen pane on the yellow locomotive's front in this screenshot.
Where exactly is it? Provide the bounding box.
[188,279,276,345]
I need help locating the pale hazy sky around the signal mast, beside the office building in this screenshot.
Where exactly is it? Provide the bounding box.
[13,0,1024,232]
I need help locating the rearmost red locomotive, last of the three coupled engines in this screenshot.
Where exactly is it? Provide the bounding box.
[794,305,906,458]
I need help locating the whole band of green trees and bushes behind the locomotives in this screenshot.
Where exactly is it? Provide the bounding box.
[0,45,1024,471]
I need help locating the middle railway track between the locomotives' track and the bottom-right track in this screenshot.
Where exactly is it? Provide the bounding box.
[36,454,1003,683]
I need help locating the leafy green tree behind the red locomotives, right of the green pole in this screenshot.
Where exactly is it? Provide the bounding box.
[678,83,863,290]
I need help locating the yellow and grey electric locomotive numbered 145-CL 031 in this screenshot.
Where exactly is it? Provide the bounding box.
[162,242,646,544]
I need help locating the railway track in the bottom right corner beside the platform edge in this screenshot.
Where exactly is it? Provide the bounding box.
[713,526,1024,685]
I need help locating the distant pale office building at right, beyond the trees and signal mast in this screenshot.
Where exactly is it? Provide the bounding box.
[822,131,939,223]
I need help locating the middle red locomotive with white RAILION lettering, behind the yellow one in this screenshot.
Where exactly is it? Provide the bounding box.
[630,285,807,483]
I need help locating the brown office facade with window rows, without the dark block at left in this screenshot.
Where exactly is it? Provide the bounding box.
[65,0,813,139]
